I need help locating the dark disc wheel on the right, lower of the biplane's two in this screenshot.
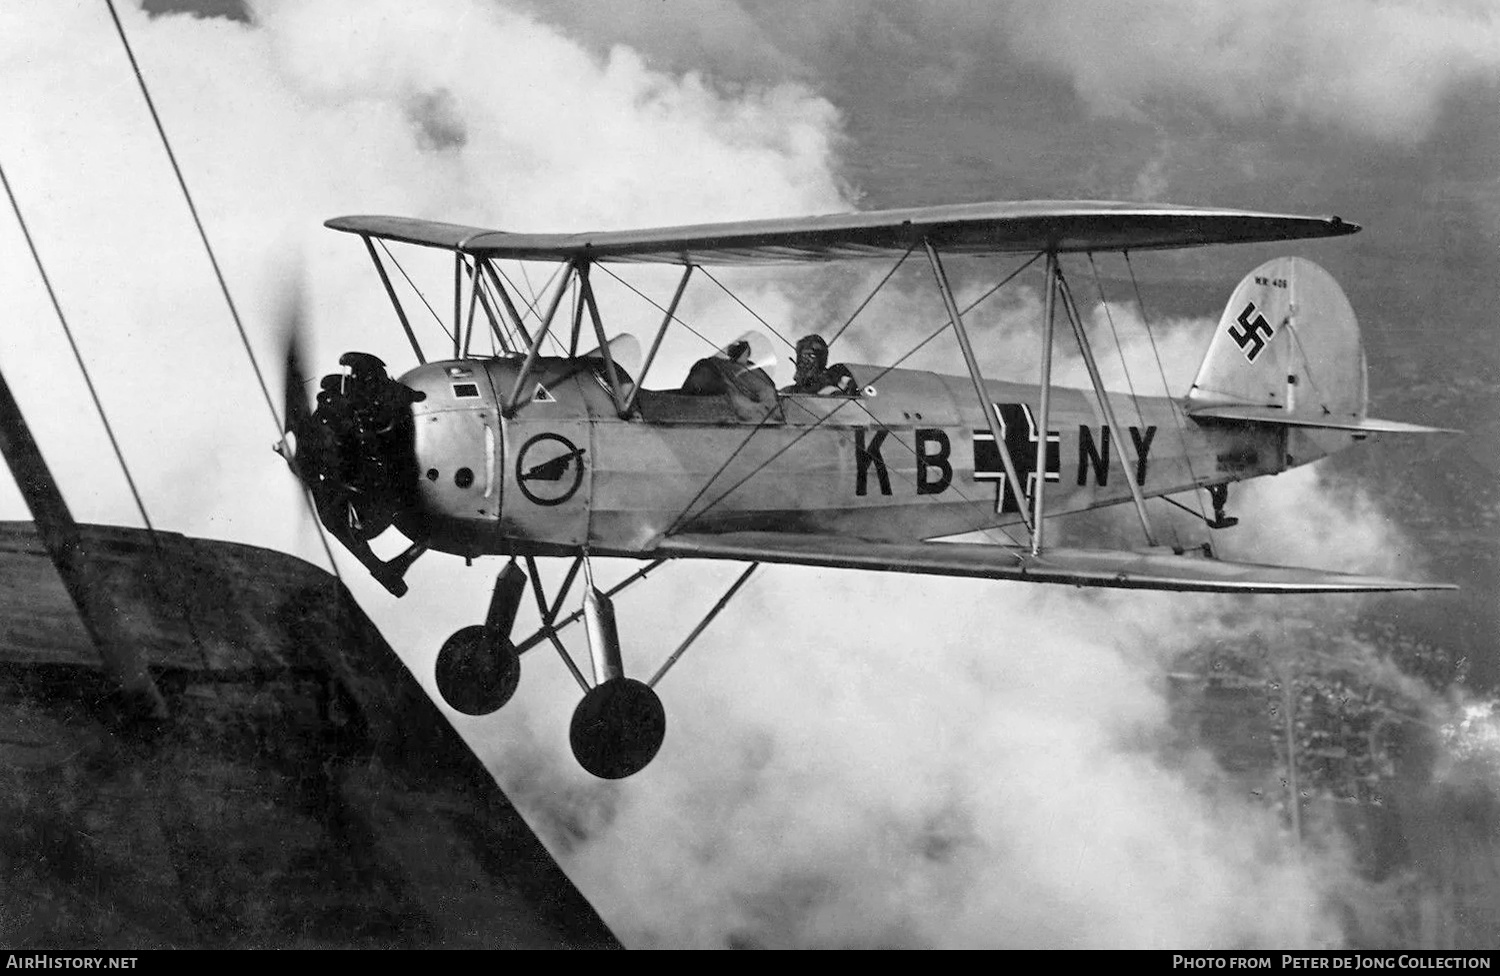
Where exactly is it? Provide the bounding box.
[569,678,666,780]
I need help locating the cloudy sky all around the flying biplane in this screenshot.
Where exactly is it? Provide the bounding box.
[0,0,1500,946]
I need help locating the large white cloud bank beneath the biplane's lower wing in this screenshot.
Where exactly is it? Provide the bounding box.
[498,568,1374,946]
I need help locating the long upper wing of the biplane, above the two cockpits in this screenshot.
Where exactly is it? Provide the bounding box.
[327,199,1359,264]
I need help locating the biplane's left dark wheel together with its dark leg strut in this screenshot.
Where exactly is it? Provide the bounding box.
[437,559,527,715]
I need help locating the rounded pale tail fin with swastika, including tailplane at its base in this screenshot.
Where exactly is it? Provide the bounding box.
[1188,258,1439,435]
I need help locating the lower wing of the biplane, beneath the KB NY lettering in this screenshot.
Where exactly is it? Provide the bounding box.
[653,532,1457,594]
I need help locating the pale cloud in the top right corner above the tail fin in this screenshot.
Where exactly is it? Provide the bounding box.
[1001,0,1500,142]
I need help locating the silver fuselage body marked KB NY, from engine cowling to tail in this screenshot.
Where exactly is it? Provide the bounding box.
[402,358,1314,555]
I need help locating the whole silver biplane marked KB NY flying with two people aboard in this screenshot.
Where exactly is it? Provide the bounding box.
[279,201,1445,778]
